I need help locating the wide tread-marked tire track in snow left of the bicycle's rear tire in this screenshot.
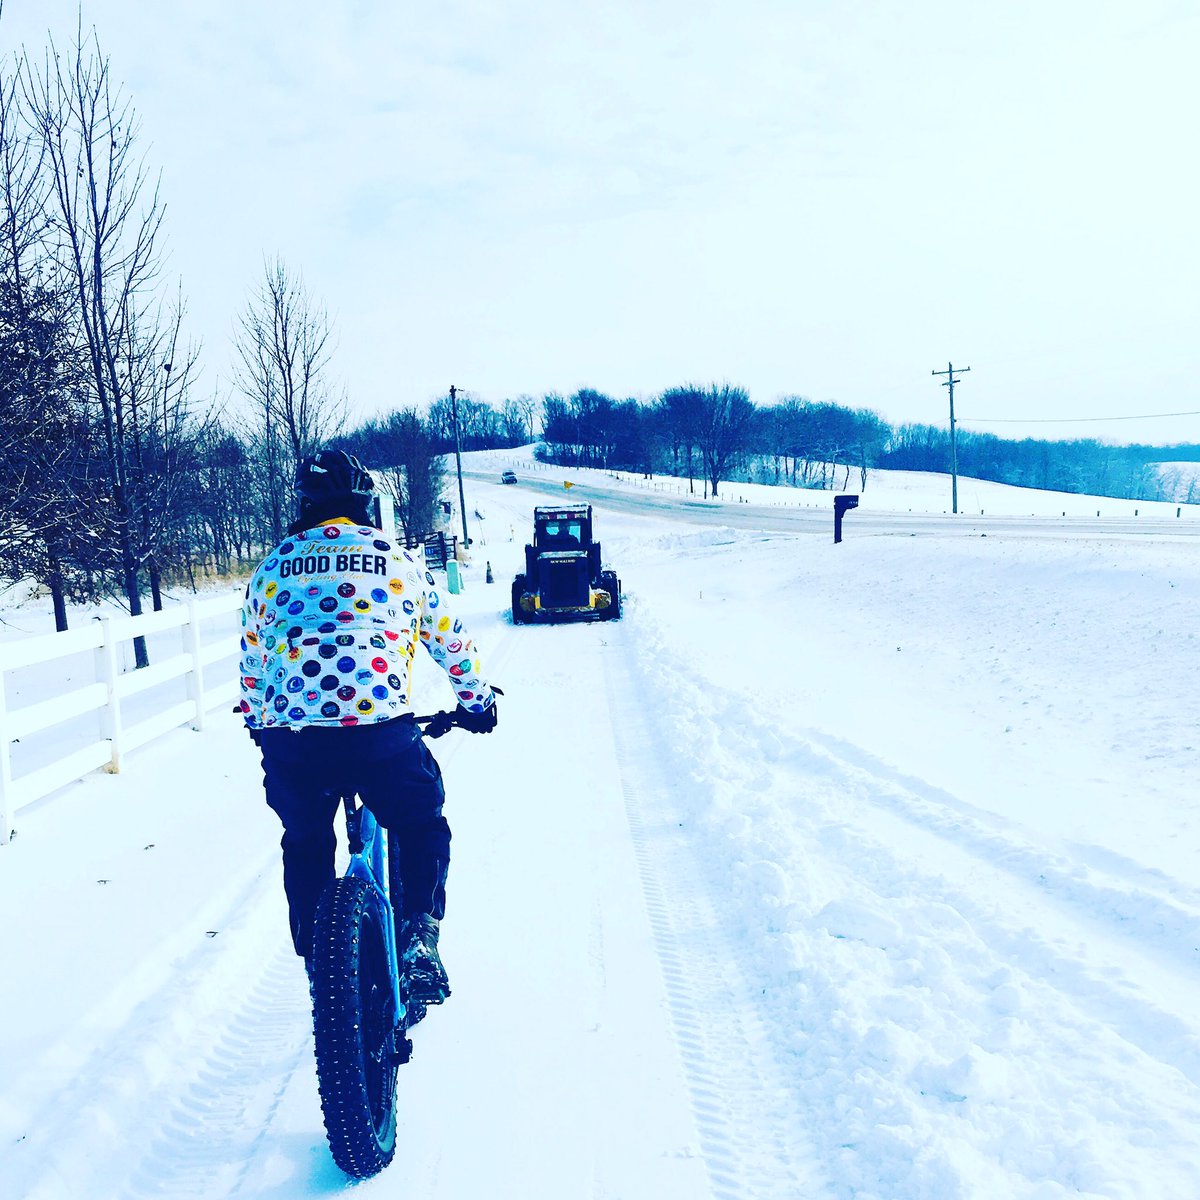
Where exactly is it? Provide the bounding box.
[20,868,311,1200]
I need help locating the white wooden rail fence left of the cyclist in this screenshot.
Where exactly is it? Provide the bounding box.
[0,589,242,845]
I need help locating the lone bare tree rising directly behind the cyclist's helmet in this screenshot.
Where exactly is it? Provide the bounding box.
[236,258,346,540]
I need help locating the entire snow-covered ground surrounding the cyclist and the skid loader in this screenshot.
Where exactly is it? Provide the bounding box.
[0,455,1200,1200]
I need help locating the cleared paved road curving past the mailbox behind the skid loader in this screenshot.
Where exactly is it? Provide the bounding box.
[463,467,1200,540]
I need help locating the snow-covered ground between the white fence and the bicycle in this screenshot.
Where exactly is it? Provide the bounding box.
[0,718,308,1200]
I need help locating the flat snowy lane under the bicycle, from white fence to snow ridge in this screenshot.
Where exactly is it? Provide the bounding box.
[0,576,822,1200]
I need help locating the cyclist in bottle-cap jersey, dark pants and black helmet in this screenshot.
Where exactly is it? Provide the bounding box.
[241,450,497,1004]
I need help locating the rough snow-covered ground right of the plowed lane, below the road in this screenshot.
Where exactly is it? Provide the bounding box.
[631,525,1200,1198]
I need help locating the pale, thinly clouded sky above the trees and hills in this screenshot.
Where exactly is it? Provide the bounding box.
[0,0,1200,443]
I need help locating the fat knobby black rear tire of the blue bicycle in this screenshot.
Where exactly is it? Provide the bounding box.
[312,877,398,1178]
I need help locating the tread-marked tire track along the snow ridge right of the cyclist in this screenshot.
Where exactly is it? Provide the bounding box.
[605,629,827,1200]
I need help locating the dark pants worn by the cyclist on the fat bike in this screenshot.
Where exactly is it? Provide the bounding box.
[258,715,450,958]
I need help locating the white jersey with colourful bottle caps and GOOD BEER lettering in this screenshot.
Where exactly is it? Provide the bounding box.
[241,520,496,728]
